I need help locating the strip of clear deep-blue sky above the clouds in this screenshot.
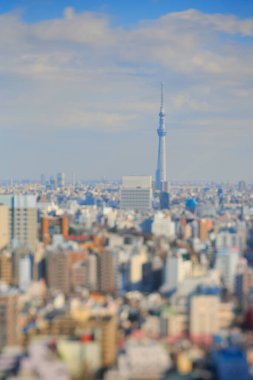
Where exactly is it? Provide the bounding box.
[0,0,253,22]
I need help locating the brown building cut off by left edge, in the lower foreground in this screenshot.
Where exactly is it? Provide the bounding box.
[0,291,18,350]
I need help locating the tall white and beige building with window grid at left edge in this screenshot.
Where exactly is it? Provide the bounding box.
[0,194,37,250]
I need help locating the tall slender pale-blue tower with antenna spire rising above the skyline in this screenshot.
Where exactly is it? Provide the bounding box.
[156,83,167,190]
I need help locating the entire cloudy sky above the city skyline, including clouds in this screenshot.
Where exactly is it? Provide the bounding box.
[0,0,253,181]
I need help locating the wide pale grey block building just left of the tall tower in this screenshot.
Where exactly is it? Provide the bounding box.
[120,176,152,211]
